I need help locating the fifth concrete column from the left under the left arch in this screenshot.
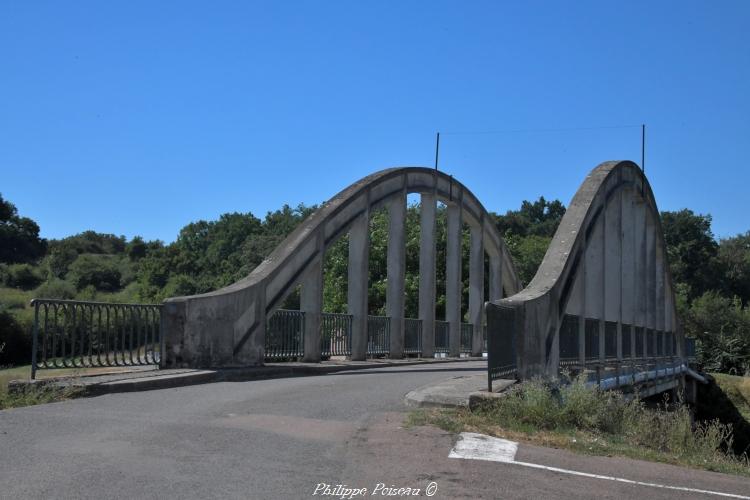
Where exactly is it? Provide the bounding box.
[445,203,462,358]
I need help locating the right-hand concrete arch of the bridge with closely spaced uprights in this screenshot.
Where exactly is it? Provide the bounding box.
[486,161,682,378]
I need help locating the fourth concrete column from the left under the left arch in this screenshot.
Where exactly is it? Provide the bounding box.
[419,193,437,358]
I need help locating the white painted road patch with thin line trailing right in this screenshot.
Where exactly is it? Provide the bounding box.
[448,432,750,500]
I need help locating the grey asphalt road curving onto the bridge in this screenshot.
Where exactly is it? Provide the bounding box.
[0,362,750,499]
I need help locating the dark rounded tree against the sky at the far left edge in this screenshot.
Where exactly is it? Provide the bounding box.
[0,194,47,264]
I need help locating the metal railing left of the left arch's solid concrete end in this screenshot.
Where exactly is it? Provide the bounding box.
[31,299,163,379]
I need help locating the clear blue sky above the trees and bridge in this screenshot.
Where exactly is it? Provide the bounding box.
[0,0,750,241]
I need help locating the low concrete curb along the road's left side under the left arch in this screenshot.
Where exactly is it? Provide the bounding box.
[8,358,486,397]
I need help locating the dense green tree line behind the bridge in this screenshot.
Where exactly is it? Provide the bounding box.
[0,191,750,372]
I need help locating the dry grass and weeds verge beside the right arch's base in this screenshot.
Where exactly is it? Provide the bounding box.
[406,380,750,477]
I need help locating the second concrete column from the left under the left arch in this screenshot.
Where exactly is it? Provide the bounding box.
[347,209,370,361]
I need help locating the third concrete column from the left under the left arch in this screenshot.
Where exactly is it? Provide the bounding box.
[385,190,406,359]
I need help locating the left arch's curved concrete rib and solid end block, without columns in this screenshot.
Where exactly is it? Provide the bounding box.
[162,167,521,367]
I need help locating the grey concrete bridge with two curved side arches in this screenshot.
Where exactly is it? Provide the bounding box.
[162,161,700,396]
